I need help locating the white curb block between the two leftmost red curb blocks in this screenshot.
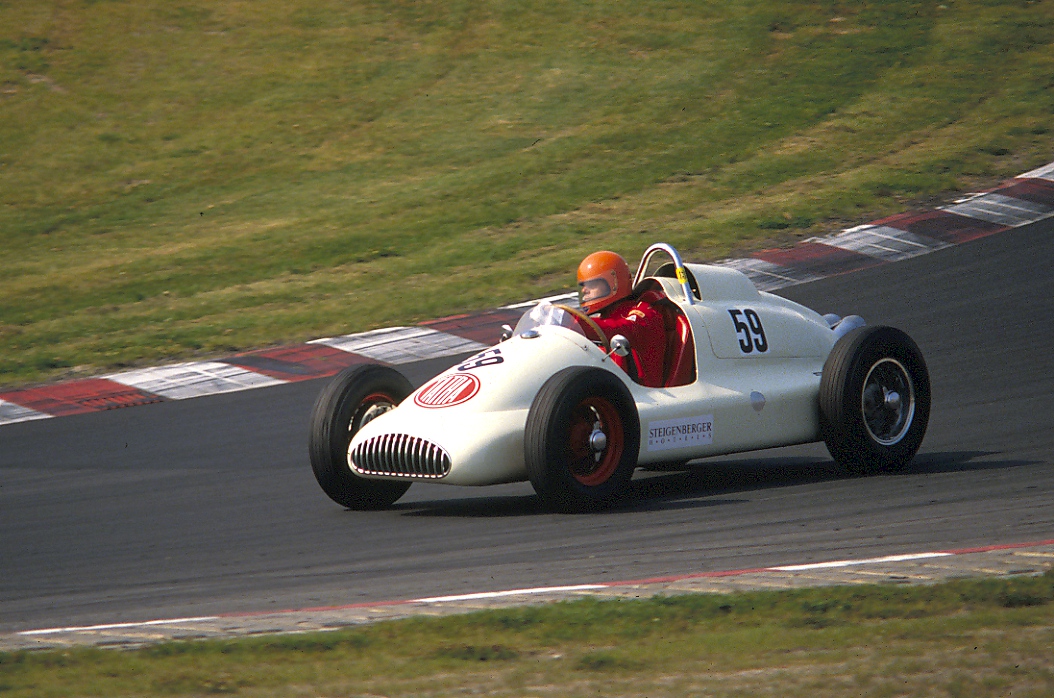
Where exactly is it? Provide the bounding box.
[103,362,286,400]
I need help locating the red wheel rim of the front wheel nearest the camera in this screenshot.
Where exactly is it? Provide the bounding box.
[567,398,625,487]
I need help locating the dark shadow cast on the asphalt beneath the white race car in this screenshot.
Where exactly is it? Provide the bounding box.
[393,451,1037,518]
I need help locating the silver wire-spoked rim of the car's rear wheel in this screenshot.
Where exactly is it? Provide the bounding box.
[860,358,915,446]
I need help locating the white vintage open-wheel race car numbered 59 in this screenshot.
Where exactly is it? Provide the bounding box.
[309,244,930,511]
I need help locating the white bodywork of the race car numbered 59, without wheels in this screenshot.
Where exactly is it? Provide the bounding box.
[349,246,839,485]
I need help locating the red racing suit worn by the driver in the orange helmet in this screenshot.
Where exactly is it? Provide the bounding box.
[593,291,666,388]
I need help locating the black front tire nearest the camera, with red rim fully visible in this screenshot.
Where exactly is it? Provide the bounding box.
[524,366,641,513]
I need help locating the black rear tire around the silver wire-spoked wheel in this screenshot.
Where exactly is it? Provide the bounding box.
[820,326,930,474]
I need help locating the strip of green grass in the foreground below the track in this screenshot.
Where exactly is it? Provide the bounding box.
[0,573,1054,698]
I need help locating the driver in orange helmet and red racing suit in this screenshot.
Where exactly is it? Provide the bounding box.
[579,251,666,388]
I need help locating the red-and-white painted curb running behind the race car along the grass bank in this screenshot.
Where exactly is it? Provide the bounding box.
[0,162,1054,425]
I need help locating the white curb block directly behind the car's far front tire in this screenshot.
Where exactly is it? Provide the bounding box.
[308,327,487,366]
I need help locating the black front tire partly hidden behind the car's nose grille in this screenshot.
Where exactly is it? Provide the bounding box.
[308,364,413,509]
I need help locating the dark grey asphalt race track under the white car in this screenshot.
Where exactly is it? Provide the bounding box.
[0,218,1054,632]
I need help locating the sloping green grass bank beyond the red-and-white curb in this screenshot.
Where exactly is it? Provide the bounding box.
[0,0,1054,386]
